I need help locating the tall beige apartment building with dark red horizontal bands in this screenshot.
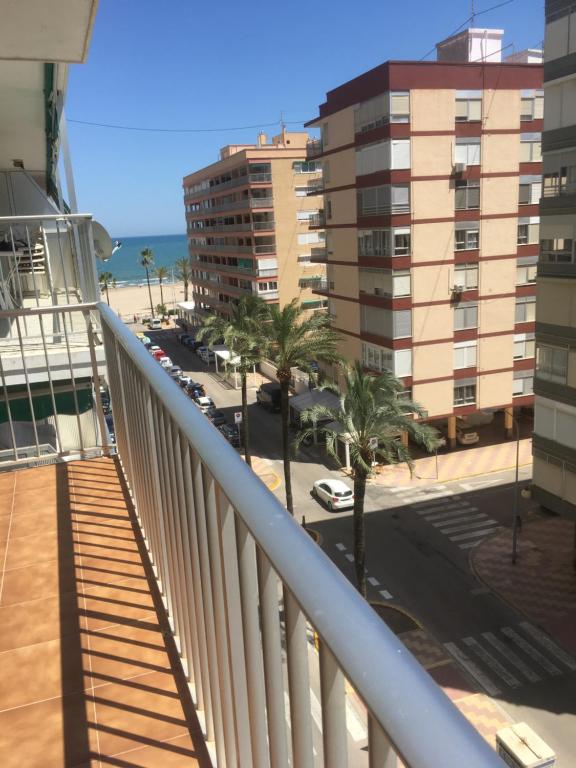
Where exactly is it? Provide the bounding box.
[309,29,542,444]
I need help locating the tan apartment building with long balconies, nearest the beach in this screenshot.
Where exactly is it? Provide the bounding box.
[183,130,327,318]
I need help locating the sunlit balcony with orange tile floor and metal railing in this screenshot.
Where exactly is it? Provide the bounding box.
[0,297,501,768]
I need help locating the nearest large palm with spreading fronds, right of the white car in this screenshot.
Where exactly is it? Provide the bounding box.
[298,361,442,597]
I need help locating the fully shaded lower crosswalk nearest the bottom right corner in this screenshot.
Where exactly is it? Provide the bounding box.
[444,621,576,696]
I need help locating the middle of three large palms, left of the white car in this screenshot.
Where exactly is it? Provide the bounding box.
[263,299,341,515]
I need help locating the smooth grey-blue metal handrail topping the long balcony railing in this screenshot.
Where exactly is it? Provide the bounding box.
[99,303,502,768]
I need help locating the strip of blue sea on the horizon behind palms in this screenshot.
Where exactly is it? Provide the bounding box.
[97,235,188,286]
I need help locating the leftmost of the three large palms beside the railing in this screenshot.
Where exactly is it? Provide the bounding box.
[197,294,268,466]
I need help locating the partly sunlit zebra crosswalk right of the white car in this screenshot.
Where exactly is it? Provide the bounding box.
[395,485,501,549]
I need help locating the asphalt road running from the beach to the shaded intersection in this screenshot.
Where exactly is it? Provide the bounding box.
[142,332,576,768]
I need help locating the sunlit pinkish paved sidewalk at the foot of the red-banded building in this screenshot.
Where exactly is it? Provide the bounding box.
[370,439,532,486]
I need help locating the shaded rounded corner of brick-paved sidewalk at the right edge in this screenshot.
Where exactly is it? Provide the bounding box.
[471,517,576,653]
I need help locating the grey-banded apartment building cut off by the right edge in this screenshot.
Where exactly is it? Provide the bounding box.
[533,0,576,519]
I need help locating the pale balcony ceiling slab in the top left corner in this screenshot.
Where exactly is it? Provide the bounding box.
[0,0,98,63]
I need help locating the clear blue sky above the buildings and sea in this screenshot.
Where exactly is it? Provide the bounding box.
[67,0,544,236]
